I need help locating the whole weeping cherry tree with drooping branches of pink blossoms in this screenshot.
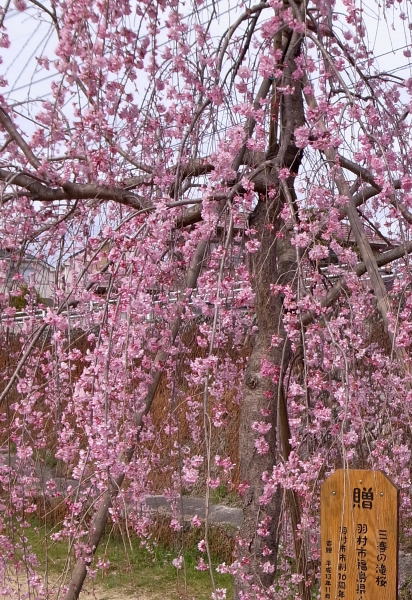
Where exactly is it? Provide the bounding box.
[0,0,412,600]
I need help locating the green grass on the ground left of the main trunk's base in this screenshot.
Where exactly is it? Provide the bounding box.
[25,521,233,600]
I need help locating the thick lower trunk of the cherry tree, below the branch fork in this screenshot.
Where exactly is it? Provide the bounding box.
[238,197,296,598]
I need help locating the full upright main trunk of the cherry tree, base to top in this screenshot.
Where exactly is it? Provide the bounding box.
[237,22,306,599]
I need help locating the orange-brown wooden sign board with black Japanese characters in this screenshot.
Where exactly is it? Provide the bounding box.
[321,469,398,600]
